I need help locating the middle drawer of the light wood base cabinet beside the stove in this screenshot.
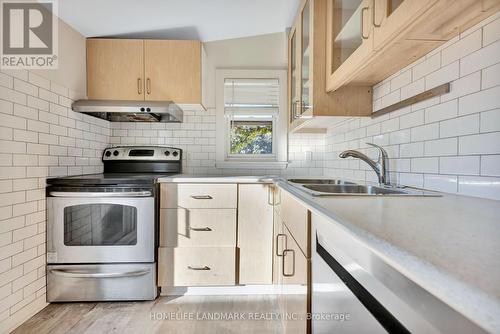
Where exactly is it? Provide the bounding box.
[160,208,236,247]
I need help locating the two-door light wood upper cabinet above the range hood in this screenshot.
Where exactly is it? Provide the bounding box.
[87,38,204,107]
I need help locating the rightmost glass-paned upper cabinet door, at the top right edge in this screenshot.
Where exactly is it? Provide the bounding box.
[373,0,438,50]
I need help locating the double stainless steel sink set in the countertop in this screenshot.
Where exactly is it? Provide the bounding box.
[288,179,441,196]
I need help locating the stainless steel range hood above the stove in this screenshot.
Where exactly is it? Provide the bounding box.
[71,100,183,123]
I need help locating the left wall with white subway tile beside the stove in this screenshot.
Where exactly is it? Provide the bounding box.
[0,17,104,333]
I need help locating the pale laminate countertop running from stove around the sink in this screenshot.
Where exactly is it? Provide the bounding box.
[160,175,500,333]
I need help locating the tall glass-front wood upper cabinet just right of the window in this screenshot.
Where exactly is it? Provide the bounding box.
[288,0,372,132]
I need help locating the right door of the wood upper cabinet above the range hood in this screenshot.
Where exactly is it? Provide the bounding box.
[144,40,202,104]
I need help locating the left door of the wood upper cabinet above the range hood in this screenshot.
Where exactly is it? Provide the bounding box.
[87,39,144,100]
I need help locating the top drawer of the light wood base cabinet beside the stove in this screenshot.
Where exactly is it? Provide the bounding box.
[160,183,237,209]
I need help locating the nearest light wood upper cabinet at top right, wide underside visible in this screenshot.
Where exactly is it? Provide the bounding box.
[326,0,500,92]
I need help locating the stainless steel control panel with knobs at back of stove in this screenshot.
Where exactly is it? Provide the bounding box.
[102,146,182,161]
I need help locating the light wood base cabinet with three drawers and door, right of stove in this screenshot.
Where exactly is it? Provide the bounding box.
[158,183,273,290]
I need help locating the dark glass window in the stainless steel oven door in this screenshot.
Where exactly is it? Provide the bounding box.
[64,204,137,246]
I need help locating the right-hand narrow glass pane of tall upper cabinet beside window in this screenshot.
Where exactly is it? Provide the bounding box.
[299,1,312,115]
